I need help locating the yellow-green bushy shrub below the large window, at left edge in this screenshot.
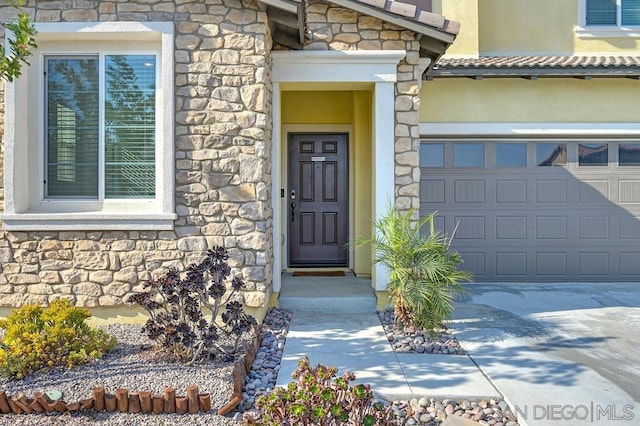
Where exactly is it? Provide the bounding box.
[0,299,116,379]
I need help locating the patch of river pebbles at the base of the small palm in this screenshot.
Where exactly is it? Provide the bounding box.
[378,309,467,355]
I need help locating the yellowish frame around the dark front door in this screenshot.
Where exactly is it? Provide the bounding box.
[279,124,354,271]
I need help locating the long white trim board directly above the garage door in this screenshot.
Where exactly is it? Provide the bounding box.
[420,123,640,138]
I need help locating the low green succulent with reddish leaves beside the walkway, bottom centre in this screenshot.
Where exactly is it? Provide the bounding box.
[256,357,388,426]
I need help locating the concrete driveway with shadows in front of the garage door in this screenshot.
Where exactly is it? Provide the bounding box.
[452,283,640,426]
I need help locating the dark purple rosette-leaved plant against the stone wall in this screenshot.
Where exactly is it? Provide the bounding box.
[127,247,256,364]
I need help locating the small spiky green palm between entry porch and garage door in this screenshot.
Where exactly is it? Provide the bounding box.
[361,207,471,330]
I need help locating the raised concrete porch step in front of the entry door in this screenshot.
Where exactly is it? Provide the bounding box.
[279,272,377,314]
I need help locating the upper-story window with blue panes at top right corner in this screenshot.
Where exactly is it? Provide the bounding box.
[584,0,640,27]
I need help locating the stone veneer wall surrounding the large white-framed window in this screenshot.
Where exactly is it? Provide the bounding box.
[0,0,273,307]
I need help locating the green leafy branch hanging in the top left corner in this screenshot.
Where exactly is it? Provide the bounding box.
[0,0,38,81]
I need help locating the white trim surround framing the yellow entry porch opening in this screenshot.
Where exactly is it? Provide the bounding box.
[271,50,406,292]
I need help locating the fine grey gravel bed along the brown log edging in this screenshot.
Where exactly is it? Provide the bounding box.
[0,324,248,426]
